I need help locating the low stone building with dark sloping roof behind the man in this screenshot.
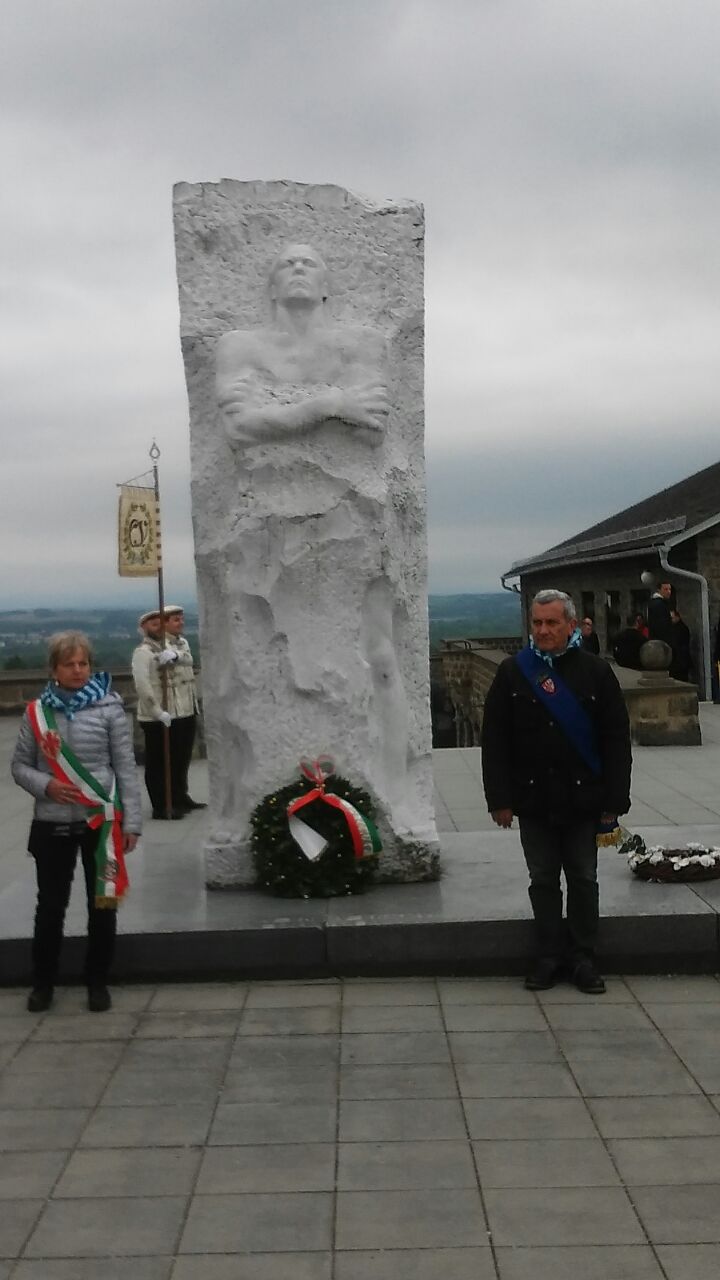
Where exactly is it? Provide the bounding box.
[502,462,720,699]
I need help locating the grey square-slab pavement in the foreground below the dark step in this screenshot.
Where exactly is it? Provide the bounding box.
[0,977,720,1280]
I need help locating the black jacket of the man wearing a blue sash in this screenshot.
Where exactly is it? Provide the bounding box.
[482,649,632,823]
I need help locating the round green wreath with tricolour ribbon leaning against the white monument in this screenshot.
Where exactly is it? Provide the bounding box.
[250,756,380,897]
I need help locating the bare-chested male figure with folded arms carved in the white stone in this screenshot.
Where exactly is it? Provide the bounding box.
[217,244,410,829]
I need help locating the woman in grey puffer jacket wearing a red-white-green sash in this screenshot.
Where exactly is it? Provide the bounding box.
[13,631,141,1012]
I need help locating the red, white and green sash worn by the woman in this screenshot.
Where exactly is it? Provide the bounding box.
[27,698,129,908]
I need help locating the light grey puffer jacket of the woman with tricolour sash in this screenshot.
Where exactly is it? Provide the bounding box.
[12,694,142,835]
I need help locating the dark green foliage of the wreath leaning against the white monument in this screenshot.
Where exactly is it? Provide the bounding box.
[250,774,378,897]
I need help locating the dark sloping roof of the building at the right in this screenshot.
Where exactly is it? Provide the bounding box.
[512,462,720,570]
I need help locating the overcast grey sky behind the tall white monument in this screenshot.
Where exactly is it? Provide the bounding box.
[0,0,720,608]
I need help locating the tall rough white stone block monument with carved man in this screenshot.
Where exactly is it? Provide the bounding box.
[174,180,438,887]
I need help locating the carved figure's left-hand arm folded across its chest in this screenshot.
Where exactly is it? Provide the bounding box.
[217,333,388,447]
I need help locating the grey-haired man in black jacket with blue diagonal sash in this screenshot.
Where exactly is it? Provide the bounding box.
[482,590,632,995]
